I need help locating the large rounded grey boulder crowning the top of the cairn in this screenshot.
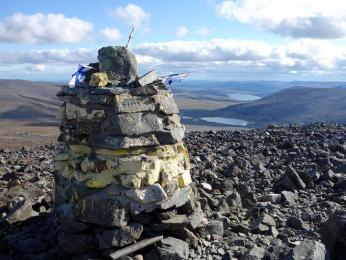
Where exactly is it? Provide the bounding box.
[97,46,137,82]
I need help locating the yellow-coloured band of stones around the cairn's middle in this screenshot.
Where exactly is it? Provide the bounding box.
[55,143,191,188]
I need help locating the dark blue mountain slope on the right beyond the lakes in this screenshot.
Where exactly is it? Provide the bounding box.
[209,87,346,126]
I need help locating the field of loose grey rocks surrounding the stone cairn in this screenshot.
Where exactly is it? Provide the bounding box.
[0,124,346,259]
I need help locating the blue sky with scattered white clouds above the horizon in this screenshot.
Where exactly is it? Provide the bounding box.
[0,0,346,82]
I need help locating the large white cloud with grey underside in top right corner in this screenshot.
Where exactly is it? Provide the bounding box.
[217,0,346,39]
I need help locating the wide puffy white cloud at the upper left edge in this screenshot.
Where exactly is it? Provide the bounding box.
[0,13,93,44]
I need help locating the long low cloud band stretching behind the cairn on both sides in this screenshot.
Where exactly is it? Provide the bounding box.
[0,39,346,75]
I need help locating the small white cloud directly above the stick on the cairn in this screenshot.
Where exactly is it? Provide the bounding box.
[110,4,150,29]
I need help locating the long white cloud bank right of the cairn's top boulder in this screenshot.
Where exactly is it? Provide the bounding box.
[134,39,346,73]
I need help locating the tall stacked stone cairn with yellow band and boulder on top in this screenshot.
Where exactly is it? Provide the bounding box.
[54,47,203,259]
